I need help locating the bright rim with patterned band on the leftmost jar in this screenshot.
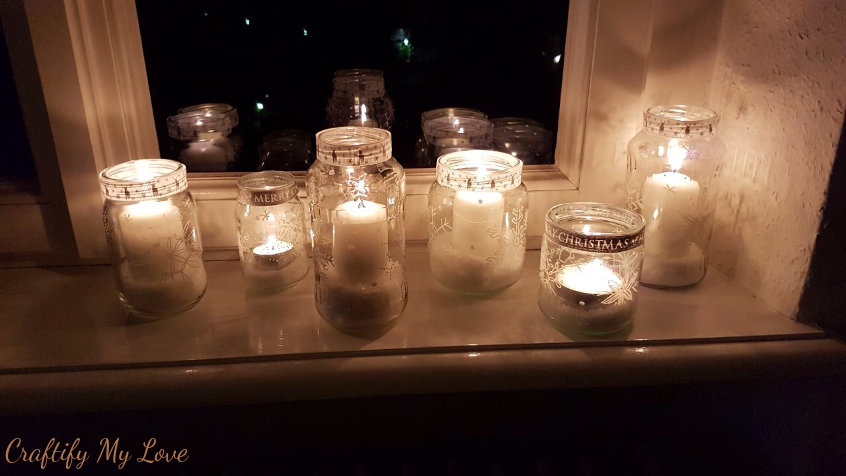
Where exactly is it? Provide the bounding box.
[98,159,188,201]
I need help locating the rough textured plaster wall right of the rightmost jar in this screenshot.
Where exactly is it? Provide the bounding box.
[709,0,846,316]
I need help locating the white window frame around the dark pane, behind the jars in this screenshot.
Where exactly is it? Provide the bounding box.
[18,0,651,261]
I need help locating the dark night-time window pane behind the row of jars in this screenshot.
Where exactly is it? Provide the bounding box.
[136,0,567,171]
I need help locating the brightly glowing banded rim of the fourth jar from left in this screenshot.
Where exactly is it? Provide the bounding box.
[435,150,523,192]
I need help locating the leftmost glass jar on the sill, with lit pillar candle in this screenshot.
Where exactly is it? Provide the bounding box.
[99,159,206,318]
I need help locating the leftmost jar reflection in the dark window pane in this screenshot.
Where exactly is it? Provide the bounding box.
[167,111,238,172]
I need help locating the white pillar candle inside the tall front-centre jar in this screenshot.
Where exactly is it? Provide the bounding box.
[332,199,388,280]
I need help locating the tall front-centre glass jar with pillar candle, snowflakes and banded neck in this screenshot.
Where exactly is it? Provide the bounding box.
[306,127,408,331]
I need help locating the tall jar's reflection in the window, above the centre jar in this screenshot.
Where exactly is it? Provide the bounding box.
[326,69,394,130]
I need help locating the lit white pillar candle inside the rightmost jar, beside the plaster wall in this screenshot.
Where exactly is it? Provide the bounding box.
[641,172,699,256]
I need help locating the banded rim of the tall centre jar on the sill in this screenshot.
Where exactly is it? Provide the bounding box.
[315,126,393,166]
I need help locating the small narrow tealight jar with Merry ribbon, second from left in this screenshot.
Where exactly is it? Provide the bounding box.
[235,171,309,292]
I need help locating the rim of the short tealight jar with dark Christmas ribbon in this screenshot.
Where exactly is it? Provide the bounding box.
[545,202,646,253]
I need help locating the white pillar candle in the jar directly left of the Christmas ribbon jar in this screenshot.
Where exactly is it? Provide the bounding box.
[452,190,505,260]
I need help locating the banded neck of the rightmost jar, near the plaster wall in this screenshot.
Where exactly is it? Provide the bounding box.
[643,105,719,138]
